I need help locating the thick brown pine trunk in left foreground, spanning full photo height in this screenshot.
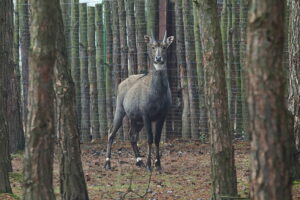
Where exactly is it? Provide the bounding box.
[24,0,59,200]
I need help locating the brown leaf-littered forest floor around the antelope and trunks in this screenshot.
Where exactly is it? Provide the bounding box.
[0,140,300,200]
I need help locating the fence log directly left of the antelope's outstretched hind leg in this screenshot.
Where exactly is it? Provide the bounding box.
[96,4,107,137]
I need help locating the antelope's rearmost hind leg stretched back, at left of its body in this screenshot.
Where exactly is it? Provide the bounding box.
[104,106,125,169]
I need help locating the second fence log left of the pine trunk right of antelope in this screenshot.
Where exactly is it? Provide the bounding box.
[182,0,199,139]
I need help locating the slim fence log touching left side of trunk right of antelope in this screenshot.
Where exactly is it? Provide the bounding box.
[193,3,207,138]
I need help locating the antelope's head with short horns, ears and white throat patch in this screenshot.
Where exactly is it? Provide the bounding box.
[144,32,174,70]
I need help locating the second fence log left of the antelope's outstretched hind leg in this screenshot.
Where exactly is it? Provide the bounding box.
[88,7,100,142]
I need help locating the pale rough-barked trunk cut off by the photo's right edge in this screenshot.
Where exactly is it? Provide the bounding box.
[288,0,300,151]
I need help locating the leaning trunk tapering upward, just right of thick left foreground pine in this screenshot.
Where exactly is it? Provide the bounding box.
[54,0,88,200]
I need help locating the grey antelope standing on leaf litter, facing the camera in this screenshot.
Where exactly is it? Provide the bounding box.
[104,33,174,170]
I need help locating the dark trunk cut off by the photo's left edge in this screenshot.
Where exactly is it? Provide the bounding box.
[0,0,14,193]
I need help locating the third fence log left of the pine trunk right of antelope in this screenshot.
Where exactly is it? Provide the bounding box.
[175,0,191,139]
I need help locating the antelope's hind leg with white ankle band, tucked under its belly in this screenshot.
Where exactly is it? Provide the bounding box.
[129,120,145,167]
